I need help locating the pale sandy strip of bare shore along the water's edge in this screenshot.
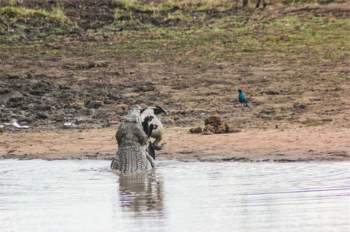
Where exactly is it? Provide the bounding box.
[0,127,350,162]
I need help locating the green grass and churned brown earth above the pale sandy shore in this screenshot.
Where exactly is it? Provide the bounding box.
[0,0,350,131]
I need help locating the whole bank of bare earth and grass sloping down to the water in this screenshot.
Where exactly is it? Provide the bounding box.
[0,3,350,161]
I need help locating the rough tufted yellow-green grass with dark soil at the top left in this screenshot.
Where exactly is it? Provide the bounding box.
[0,0,348,38]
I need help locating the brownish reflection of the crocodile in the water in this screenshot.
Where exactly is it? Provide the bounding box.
[119,172,163,216]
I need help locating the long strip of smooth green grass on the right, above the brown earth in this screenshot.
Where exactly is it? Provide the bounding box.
[97,11,350,63]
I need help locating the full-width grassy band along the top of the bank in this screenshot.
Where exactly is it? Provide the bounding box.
[0,0,350,59]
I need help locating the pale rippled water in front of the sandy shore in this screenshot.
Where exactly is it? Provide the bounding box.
[0,160,350,232]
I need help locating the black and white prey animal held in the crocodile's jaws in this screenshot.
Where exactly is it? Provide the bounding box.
[141,106,168,150]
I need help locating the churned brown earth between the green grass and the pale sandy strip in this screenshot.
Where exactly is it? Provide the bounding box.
[0,47,350,130]
